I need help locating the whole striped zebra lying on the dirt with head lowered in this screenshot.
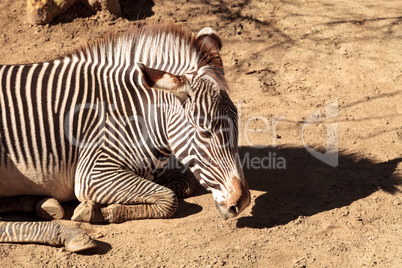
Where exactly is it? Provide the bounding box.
[0,23,250,252]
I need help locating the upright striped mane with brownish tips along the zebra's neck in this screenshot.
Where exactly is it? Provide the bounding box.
[67,23,228,91]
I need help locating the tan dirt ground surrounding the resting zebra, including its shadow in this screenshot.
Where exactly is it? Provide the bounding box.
[0,0,402,267]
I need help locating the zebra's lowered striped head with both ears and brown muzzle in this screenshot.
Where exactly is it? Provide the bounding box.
[139,28,250,220]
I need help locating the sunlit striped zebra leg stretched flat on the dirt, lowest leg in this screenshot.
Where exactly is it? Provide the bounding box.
[0,222,96,252]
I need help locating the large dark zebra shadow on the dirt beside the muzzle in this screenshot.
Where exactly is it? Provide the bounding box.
[237,147,402,228]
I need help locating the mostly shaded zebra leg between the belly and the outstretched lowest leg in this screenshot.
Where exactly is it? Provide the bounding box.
[0,195,64,220]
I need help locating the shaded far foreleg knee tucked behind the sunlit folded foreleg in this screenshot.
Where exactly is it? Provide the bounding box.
[156,168,197,198]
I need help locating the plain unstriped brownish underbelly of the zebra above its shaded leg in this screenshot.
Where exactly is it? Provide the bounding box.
[0,158,75,202]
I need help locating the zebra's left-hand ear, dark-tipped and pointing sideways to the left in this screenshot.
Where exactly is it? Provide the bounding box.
[137,63,190,102]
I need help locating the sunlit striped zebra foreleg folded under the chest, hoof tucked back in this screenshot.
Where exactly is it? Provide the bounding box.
[71,169,178,223]
